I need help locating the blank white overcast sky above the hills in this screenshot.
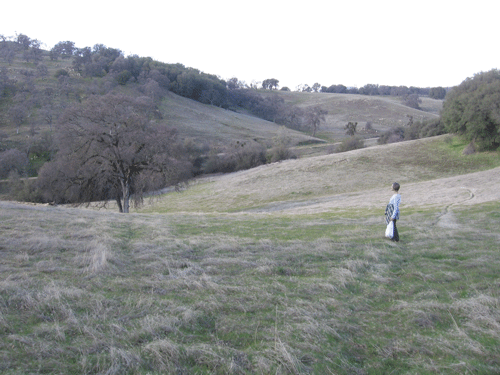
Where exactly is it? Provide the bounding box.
[0,0,500,90]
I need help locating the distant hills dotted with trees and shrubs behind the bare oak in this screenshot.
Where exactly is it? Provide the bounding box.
[0,34,441,191]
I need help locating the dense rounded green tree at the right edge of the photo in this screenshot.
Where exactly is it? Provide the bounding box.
[441,69,500,150]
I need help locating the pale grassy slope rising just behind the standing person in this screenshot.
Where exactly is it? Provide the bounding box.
[143,136,500,213]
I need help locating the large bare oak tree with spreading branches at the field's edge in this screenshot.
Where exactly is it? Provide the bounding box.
[40,95,191,213]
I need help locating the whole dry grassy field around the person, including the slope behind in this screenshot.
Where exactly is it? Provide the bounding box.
[0,137,500,374]
